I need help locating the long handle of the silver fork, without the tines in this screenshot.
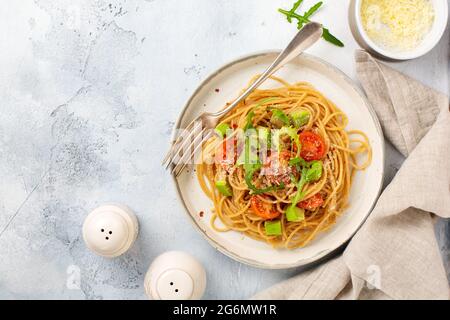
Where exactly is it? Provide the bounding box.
[215,22,322,116]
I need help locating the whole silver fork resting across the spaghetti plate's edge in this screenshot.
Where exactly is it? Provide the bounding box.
[162,22,322,177]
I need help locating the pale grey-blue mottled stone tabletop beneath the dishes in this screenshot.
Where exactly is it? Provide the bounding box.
[0,0,450,299]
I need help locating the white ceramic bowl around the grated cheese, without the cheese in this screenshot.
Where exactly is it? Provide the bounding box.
[349,0,448,60]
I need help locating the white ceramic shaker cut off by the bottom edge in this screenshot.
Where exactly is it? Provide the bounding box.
[144,251,206,300]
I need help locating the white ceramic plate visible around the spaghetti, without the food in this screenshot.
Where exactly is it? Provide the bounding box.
[174,52,384,269]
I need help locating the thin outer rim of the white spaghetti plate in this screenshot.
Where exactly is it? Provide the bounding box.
[171,49,385,270]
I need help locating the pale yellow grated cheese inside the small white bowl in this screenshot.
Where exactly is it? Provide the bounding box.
[360,0,434,51]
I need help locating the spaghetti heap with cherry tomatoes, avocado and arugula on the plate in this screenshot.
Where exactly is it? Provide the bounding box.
[197,77,372,249]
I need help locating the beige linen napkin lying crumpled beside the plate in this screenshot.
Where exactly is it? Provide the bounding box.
[253,50,450,299]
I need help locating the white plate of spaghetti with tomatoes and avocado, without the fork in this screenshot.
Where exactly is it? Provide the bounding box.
[175,52,384,269]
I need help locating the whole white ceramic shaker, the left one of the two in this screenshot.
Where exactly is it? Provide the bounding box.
[83,204,138,258]
